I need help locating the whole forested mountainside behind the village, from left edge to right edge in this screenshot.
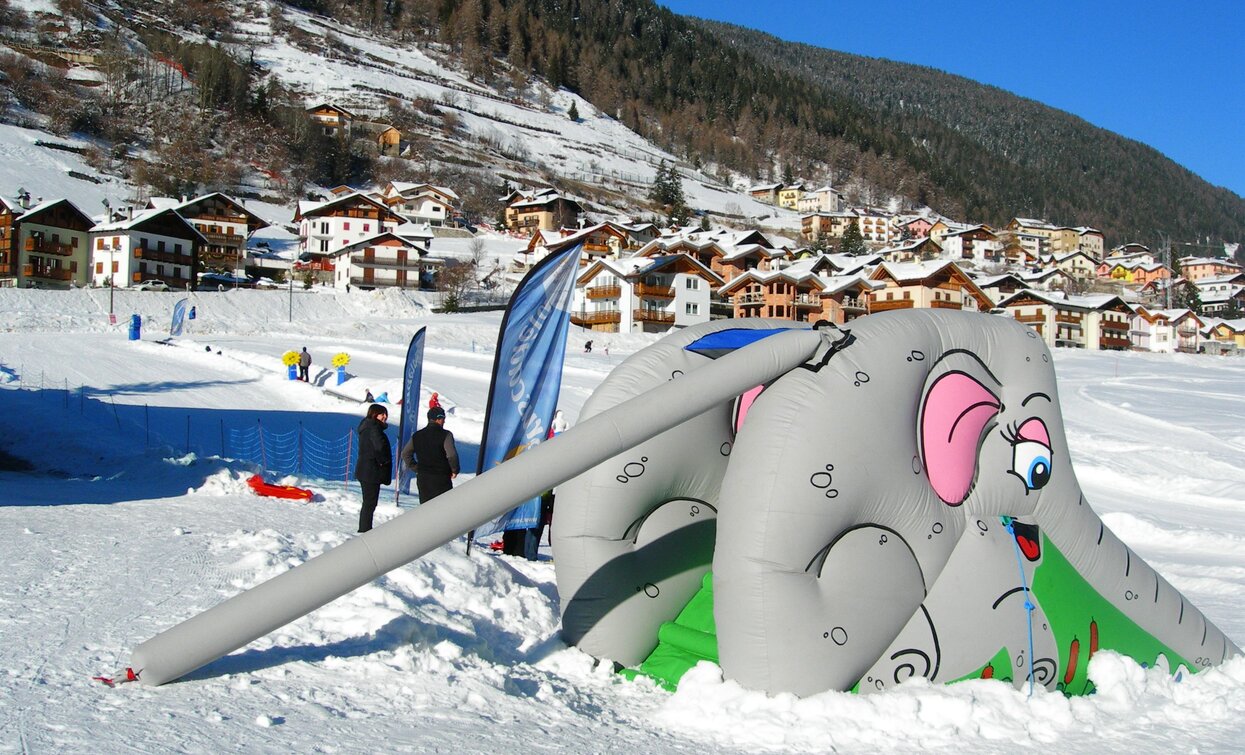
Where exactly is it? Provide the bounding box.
[0,0,1245,252]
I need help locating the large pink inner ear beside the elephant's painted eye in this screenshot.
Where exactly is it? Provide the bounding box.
[920,373,1000,506]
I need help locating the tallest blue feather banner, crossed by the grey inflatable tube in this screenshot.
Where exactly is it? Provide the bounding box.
[468,242,584,543]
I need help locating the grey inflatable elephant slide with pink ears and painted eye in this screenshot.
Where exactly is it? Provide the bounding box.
[553,310,1240,695]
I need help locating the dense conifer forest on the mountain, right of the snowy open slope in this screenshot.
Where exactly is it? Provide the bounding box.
[406,0,1245,248]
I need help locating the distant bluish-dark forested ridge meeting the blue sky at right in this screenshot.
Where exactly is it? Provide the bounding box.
[695,20,1245,251]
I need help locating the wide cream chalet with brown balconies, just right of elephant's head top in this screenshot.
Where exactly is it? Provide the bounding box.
[998,289,1133,350]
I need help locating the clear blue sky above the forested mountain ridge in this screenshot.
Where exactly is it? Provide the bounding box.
[659,0,1245,197]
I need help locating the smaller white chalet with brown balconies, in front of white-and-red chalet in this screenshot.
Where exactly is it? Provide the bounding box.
[329,224,444,290]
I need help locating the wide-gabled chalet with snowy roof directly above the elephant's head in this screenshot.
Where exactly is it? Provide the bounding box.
[869,262,994,311]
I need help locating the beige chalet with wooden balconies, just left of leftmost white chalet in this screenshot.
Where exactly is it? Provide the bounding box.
[9,199,95,289]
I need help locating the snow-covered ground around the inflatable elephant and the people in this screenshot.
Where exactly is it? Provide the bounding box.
[0,289,1245,753]
